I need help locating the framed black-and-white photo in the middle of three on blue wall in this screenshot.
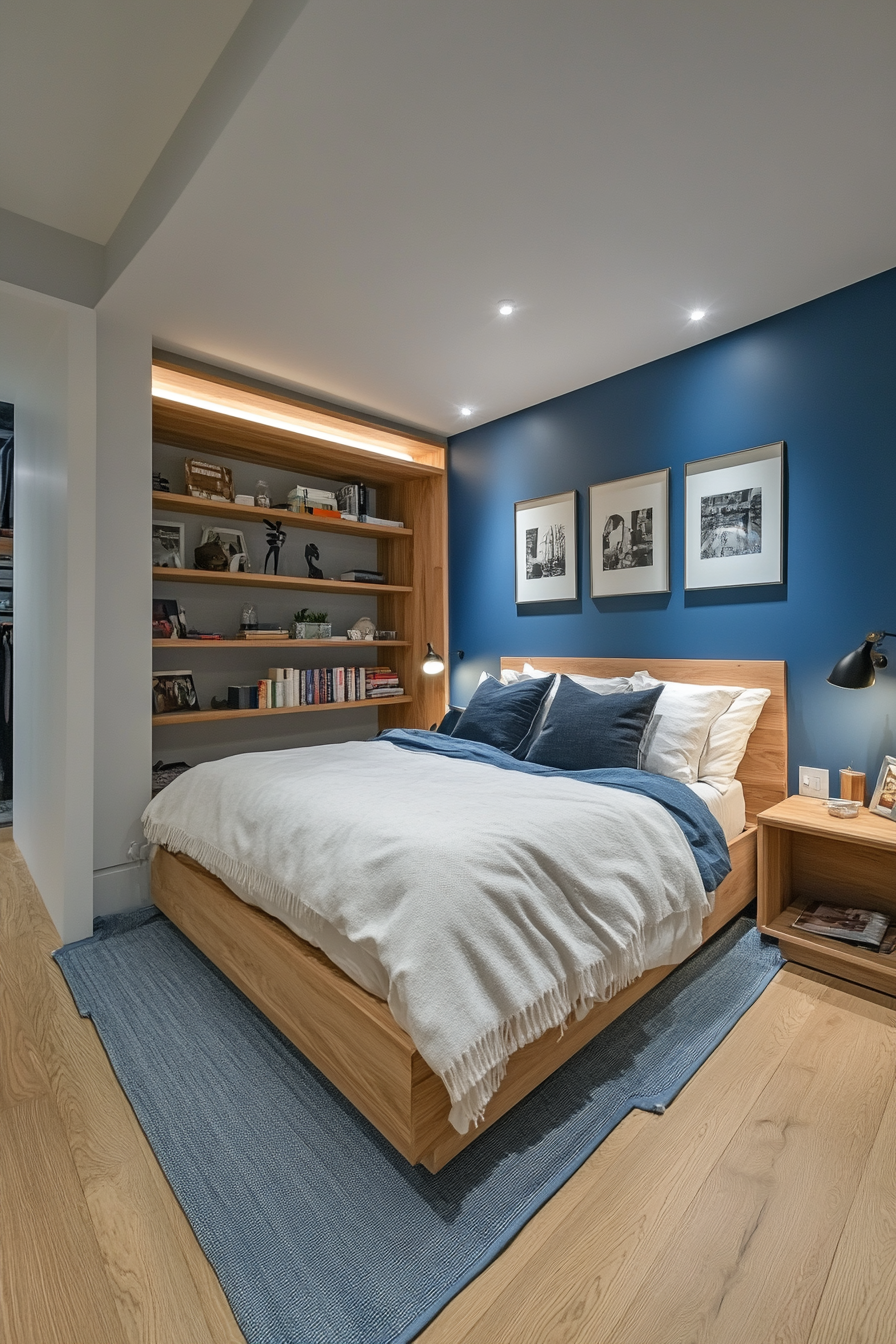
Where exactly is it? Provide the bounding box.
[588,466,669,597]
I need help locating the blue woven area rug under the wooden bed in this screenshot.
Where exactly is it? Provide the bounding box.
[55,909,782,1344]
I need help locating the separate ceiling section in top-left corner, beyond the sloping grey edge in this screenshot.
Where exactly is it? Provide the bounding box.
[0,0,249,243]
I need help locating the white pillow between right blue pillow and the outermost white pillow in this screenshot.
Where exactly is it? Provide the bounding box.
[631,672,737,784]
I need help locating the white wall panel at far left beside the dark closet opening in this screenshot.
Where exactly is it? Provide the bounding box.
[0,282,97,942]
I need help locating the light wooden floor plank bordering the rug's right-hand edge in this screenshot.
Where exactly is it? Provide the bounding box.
[420,968,829,1344]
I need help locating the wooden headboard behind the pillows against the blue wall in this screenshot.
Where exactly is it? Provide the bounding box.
[501,655,787,824]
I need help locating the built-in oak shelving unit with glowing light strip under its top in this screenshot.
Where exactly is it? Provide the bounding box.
[152,353,447,728]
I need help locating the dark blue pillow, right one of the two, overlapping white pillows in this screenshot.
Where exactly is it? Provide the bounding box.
[525,676,662,770]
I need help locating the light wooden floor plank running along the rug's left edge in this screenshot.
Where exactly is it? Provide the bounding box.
[0,856,243,1344]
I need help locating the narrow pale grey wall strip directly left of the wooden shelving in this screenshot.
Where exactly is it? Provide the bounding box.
[93,304,152,914]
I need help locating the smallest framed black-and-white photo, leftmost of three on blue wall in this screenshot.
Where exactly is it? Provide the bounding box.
[513,491,579,602]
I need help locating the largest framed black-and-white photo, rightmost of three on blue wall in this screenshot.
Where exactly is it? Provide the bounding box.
[685,444,785,589]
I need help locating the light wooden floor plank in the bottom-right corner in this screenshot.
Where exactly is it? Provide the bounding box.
[809,1026,896,1344]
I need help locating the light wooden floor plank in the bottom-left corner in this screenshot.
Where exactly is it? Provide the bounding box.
[0,1097,125,1344]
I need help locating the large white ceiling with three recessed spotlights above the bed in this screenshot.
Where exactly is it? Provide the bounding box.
[87,0,896,433]
